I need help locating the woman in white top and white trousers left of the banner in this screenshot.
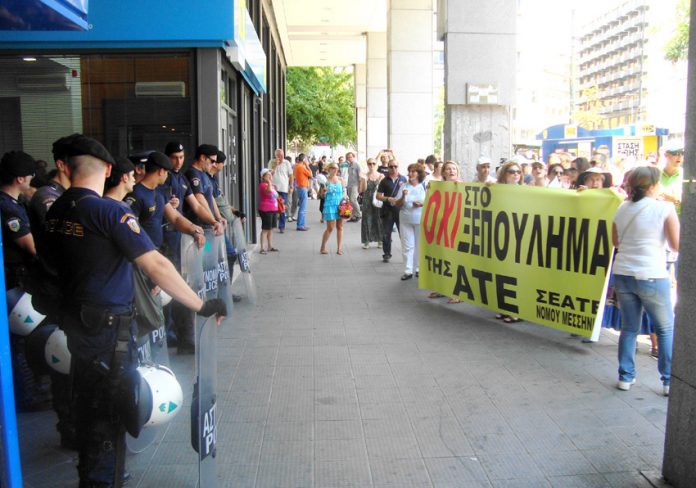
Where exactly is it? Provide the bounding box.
[394,164,425,281]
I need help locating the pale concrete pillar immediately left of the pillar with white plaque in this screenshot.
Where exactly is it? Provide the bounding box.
[387,0,434,166]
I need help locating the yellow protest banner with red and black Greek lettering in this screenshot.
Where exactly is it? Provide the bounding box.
[419,181,621,337]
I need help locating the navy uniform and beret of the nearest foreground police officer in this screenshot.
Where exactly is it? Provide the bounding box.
[45,137,155,488]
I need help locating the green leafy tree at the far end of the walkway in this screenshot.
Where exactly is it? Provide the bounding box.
[286,67,356,147]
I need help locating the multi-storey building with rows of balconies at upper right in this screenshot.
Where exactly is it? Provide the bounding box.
[577,0,686,136]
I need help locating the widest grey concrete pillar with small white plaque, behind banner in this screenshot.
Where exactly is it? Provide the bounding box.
[438,0,517,180]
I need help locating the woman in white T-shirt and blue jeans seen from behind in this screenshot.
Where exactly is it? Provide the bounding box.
[612,166,679,396]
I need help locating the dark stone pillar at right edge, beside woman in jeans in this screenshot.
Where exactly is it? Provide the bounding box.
[662,1,696,488]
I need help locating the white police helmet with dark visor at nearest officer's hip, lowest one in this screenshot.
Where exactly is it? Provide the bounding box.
[117,364,184,437]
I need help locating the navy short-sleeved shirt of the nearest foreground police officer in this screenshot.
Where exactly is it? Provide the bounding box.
[44,187,155,312]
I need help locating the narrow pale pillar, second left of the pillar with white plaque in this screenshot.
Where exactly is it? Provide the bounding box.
[366,32,389,158]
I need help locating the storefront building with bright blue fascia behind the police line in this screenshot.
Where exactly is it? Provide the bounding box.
[0,0,286,239]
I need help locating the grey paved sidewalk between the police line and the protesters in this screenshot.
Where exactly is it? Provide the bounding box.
[20,200,667,488]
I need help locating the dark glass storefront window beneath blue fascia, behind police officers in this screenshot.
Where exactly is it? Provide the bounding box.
[0,52,195,165]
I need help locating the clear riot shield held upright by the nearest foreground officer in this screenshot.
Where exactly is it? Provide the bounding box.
[191,317,217,488]
